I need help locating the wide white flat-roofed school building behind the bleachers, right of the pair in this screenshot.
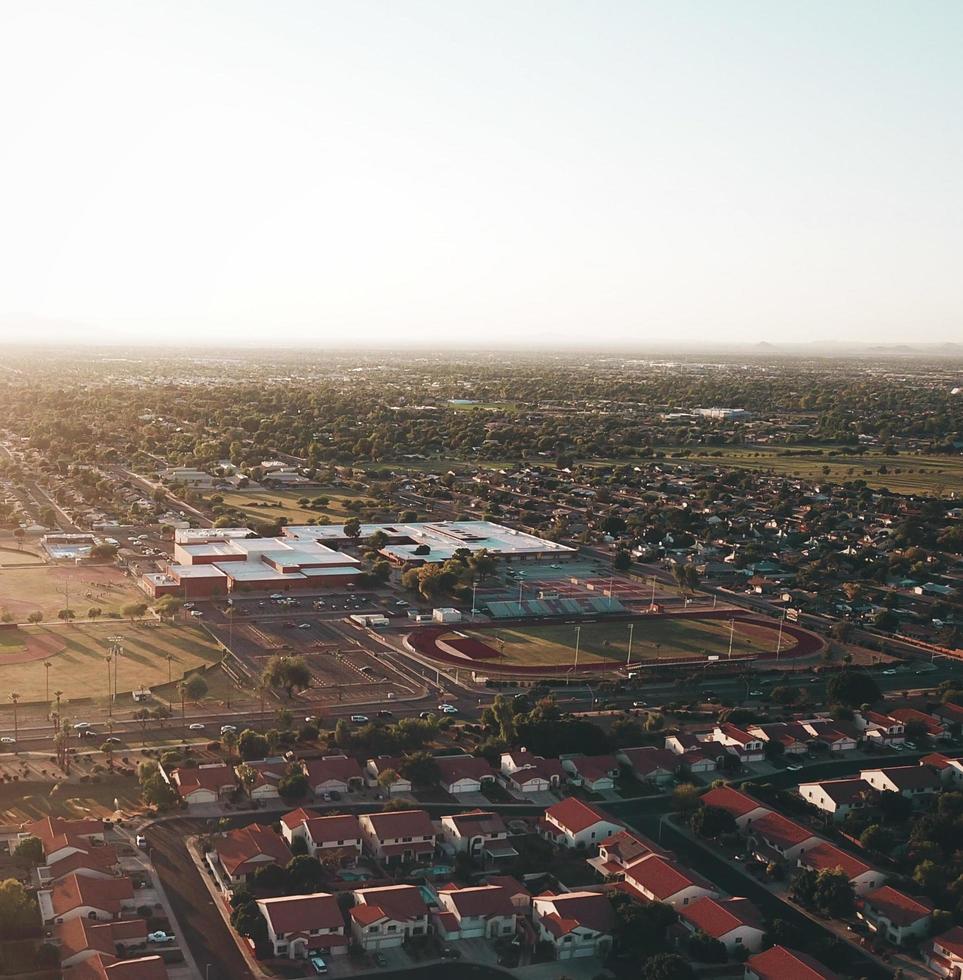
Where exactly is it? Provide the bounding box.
[283,521,576,565]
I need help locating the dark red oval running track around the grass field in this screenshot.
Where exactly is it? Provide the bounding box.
[405,609,825,676]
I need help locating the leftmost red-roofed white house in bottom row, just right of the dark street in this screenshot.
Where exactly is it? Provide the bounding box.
[257,892,348,959]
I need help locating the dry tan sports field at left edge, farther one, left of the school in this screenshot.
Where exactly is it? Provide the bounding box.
[0,565,145,622]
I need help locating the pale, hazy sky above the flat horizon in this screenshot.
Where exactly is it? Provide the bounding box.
[0,0,963,347]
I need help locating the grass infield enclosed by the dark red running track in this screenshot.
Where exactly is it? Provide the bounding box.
[465,617,792,666]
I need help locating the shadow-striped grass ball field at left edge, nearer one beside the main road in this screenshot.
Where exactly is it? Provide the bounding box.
[0,621,221,710]
